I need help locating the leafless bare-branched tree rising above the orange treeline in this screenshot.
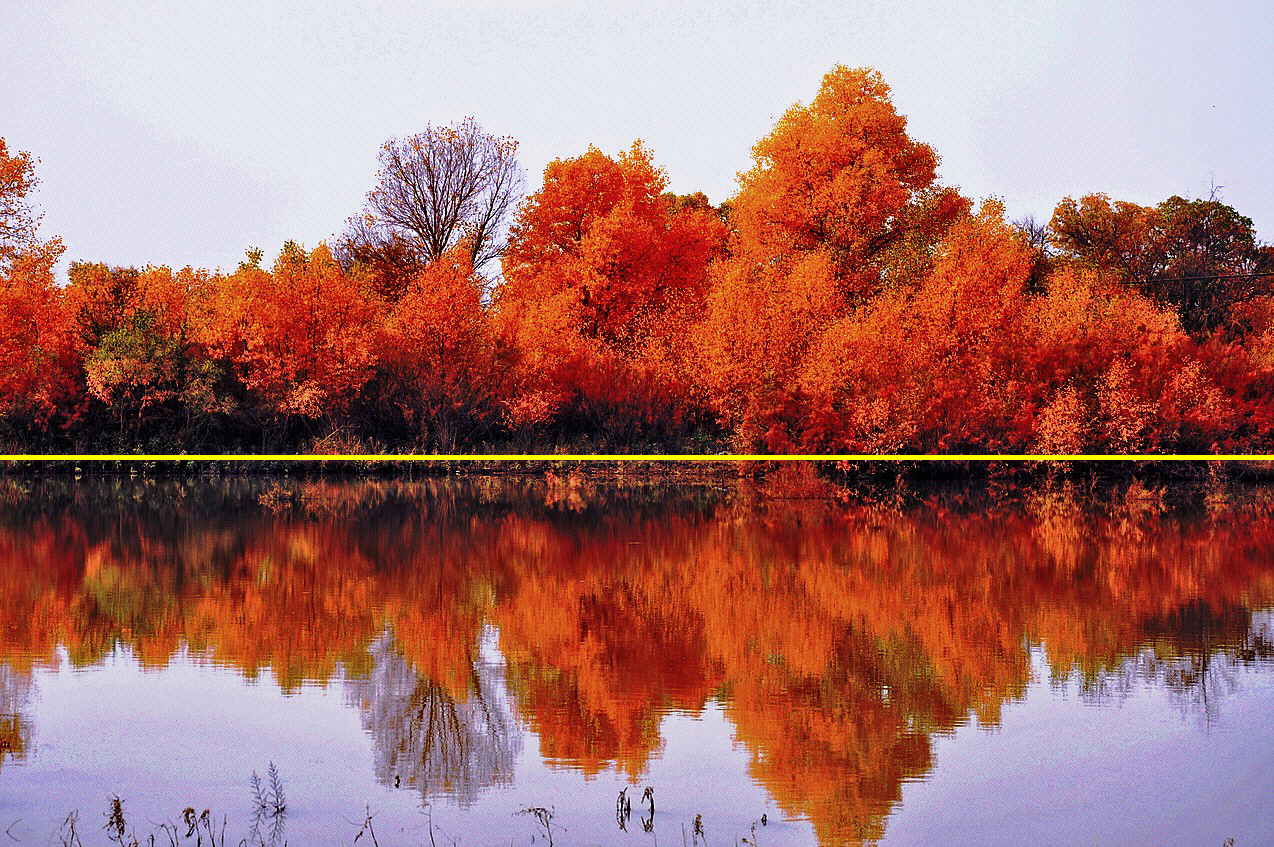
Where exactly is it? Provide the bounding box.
[339,117,525,292]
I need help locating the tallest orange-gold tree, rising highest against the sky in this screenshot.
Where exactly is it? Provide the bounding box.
[697,66,968,443]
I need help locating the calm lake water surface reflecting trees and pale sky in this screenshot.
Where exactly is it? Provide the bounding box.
[0,478,1274,847]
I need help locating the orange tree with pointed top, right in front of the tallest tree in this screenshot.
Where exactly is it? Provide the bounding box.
[801,204,1033,452]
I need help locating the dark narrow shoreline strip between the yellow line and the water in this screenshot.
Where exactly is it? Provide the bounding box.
[0,453,1274,489]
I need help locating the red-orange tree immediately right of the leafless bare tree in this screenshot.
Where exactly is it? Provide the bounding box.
[497,141,725,434]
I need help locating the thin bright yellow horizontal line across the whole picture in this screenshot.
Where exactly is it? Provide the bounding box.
[0,453,1274,462]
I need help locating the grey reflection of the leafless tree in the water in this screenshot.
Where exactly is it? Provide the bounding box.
[347,633,522,806]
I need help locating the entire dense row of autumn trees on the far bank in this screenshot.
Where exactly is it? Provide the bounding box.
[0,68,1274,452]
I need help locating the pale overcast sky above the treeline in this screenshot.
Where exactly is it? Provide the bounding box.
[0,0,1274,273]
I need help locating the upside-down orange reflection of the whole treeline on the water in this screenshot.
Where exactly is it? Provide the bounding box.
[0,480,1274,843]
